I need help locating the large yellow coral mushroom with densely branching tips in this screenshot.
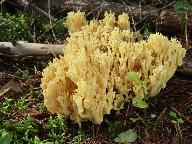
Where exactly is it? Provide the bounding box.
[41,12,186,124]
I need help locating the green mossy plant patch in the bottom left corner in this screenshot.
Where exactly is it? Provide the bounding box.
[0,115,59,144]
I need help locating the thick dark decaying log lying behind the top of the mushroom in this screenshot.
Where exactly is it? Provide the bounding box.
[15,0,192,34]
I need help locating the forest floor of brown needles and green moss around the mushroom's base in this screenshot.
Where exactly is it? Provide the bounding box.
[0,0,192,144]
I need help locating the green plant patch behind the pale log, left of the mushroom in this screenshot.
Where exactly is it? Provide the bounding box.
[0,10,67,42]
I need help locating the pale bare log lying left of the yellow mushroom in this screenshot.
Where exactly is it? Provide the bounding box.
[0,41,63,56]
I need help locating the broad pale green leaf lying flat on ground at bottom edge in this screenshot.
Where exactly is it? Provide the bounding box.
[114,129,137,143]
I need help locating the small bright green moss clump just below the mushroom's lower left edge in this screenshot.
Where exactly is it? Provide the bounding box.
[44,116,67,141]
